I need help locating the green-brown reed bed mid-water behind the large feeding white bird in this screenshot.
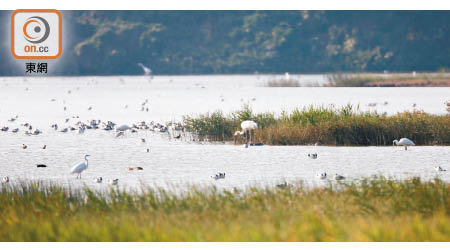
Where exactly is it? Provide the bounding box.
[184,105,450,146]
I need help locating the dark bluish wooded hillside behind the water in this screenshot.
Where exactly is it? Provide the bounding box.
[0,11,450,75]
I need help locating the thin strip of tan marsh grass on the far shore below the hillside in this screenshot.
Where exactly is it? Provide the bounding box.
[327,73,450,87]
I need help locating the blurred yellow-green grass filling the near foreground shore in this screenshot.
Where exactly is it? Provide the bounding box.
[0,177,450,241]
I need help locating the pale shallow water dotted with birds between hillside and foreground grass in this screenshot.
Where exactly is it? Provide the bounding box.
[0,75,450,188]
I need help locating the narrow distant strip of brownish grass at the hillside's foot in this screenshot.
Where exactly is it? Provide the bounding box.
[327,73,450,87]
